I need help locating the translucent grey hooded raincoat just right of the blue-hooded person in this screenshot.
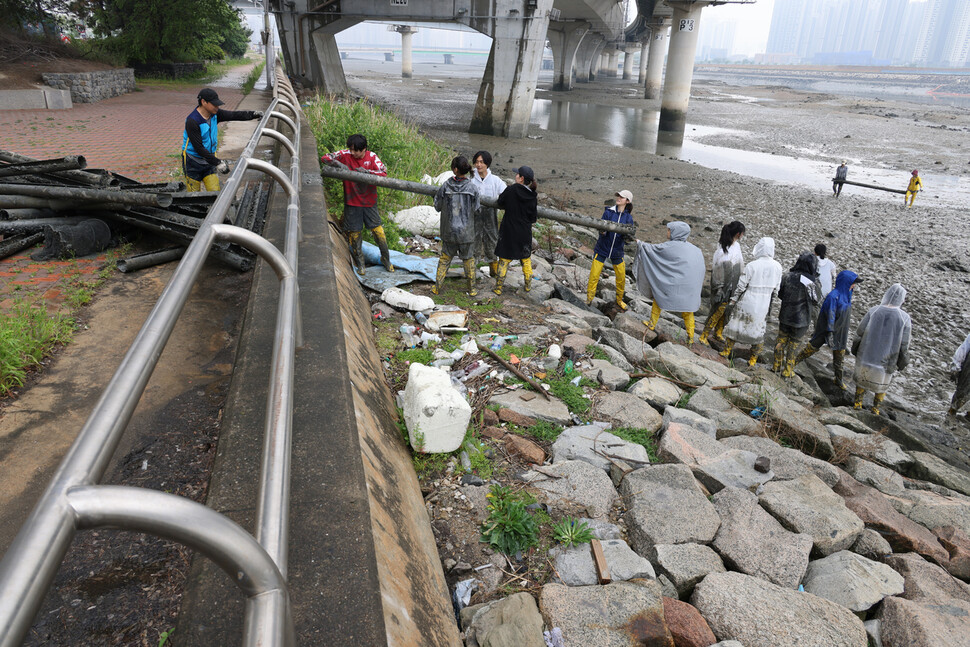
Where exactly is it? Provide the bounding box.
[852,283,913,393]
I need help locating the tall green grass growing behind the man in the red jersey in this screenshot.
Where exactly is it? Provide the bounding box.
[303,97,453,251]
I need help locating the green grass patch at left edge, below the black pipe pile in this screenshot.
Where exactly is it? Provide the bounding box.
[0,302,75,395]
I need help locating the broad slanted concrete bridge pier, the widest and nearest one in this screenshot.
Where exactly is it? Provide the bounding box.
[469,0,553,138]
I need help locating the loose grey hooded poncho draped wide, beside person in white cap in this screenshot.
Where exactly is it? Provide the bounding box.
[636,221,705,312]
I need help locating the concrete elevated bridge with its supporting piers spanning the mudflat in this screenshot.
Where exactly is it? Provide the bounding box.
[267,0,755,138]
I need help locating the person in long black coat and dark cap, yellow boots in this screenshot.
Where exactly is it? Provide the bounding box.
[492,166,539,295]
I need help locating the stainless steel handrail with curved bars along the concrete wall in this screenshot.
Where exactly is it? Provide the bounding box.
[0,52,302,647]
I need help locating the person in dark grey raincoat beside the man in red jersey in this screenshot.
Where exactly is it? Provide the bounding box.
[431,155,481,296]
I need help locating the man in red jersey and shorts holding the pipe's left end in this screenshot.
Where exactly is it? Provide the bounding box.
[320,133,394,276]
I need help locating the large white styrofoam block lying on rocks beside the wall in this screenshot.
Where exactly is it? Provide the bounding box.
[404,363,472,454]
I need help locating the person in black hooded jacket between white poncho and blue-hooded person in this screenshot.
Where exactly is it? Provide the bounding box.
[771,250,822,377]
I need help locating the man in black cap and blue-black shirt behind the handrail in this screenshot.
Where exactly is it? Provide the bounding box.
[182,88,263,191]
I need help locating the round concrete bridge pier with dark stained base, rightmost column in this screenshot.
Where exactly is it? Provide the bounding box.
[660,0,708,132]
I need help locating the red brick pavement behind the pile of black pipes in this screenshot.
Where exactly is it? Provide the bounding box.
[0,84,243,182]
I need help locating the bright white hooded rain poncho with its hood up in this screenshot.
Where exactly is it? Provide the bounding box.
[724,237,782,344]
